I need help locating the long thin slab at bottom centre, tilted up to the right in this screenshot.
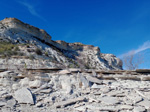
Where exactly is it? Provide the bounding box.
[55,97,85,108]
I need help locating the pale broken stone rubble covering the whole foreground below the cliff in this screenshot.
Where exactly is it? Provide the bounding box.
[0,70,150,112]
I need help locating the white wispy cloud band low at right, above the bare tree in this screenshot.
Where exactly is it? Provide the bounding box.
[118,40,150,58]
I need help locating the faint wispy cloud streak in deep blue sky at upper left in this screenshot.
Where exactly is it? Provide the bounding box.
[17,1,46,21]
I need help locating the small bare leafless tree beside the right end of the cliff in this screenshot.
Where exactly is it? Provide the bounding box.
[123,51,143,70]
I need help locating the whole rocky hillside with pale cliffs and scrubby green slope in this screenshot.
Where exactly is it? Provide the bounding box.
[0,18,122,70]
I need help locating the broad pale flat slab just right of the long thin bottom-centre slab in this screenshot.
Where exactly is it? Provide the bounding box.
[99,96,120,105]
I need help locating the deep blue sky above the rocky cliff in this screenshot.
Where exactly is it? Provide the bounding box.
[0,0,150,68]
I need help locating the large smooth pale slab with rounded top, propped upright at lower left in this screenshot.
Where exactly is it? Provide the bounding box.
[14,88,34,104]
